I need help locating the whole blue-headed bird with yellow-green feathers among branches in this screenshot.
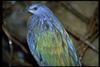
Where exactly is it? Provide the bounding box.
[27,3,81,66]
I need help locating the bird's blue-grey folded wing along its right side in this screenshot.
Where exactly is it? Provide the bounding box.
[50,16,81,65]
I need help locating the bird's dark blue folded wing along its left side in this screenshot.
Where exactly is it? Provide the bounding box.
[27,16,42,64]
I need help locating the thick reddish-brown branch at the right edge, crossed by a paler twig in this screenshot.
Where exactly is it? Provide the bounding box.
[79,7,98,60]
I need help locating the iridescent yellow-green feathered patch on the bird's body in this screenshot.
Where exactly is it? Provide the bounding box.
[36,29,70,65]
